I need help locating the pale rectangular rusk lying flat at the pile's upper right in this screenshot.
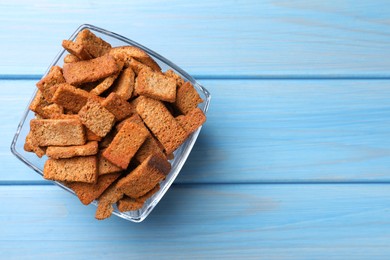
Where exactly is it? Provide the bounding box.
[135,70,176,103]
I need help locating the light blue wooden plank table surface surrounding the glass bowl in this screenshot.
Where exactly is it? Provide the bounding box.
[0,0,390,259]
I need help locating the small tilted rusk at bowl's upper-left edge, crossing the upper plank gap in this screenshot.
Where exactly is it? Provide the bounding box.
[36,66,65,102]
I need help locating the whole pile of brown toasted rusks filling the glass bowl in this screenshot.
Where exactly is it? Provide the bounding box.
[24,29,206,219]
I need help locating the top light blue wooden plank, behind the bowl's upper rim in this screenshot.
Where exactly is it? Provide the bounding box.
[0,0,390,77]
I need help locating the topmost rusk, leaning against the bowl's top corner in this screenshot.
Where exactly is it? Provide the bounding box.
[75,29,111,58]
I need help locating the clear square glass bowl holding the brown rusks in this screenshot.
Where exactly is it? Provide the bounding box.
[11,24,211,222]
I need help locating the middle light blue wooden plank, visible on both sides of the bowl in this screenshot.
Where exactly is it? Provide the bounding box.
[5,80,390,183]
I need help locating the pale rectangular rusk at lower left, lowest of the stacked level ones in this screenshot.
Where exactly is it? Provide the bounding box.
[43,156,97,183]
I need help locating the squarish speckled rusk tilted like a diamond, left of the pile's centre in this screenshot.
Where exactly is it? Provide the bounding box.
[78,99,115,137]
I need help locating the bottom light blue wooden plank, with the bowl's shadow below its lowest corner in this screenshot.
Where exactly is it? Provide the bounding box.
[0,184,390,259]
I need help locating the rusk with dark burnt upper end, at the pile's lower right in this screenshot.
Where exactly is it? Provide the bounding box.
[117,155,171,199]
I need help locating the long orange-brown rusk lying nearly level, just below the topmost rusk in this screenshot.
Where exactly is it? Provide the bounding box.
[63,55,119,85]
